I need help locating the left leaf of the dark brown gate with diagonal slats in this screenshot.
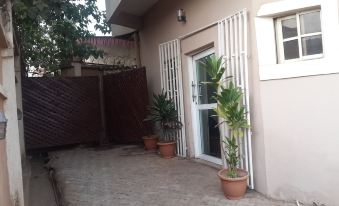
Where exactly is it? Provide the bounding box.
[22,77,101,150]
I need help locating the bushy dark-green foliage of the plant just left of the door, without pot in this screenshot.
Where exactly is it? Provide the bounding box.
[145,91,182,141]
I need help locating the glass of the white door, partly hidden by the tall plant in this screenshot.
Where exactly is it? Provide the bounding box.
[195,53,221,158]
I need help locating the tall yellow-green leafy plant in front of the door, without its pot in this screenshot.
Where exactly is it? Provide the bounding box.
[202,56,249,178]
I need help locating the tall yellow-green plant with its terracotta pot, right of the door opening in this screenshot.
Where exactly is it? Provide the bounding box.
[203,56,250,199]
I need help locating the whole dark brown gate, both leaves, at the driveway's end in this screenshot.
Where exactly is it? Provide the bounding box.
[22,68,149,150]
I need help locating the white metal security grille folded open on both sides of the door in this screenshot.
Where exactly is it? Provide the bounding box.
[159,9,254,189]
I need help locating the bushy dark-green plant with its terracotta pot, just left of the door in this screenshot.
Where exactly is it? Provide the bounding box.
[146,91,182,158]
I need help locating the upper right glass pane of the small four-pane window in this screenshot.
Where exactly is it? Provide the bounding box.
[300,11,321,34]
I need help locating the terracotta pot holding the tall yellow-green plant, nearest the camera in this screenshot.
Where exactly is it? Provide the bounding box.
[218,169,248,200]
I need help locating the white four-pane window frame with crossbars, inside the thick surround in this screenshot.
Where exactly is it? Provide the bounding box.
[275,9,324,63]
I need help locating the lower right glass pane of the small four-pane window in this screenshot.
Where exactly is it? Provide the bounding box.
[301,35,323,56]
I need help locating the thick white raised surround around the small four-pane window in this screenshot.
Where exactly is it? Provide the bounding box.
[254,0,339,81]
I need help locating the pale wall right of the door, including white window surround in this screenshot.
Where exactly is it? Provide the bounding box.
[254,0,339,205]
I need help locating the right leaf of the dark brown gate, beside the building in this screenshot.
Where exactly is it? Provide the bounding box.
[104,69,150,143]
